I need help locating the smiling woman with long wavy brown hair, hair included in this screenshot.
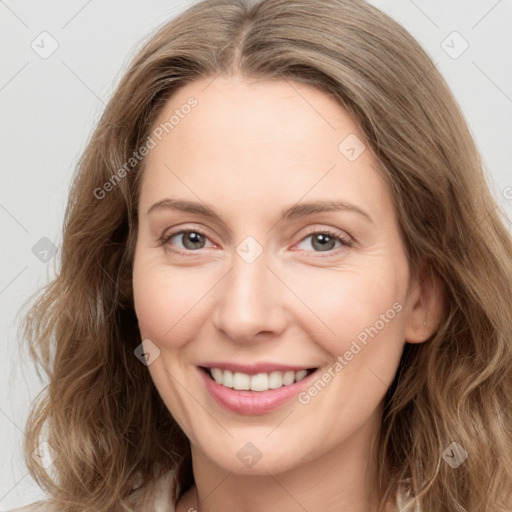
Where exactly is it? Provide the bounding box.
[14,0,512,512]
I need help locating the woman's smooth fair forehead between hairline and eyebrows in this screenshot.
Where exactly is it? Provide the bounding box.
[141,77,390,222]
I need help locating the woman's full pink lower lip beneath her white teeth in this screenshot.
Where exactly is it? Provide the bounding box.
[199,368,316,416]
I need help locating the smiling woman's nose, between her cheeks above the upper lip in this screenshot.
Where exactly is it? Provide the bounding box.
[213,254,287,343]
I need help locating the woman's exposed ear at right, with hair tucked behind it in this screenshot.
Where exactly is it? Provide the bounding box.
[405,264,444,343]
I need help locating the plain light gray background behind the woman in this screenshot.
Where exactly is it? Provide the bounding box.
[0,0,512,510]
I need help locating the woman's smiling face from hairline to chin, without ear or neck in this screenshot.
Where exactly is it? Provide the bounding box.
[133,77,424,474]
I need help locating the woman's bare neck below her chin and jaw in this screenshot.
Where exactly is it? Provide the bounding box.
[177,408,386,512]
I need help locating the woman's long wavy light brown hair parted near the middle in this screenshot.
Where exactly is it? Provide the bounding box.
[20,0,512,512]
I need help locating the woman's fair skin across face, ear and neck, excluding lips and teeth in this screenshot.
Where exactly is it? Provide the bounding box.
[133,76,440,512]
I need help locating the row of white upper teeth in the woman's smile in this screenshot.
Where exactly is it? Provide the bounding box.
[210,368,308,391]
